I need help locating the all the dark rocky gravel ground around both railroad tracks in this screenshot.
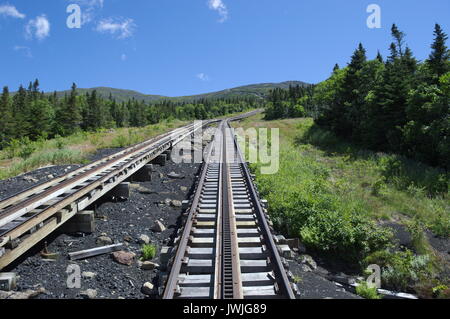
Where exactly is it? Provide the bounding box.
[0,139,359,299]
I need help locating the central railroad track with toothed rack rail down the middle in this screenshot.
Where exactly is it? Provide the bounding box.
[163,121,295,299]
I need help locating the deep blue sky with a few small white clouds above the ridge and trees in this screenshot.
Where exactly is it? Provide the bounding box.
[0,0,450,96]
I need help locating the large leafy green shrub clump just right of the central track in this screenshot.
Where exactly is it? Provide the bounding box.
[257,151,392,263]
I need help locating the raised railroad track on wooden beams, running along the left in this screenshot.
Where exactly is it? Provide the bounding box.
[0,120,217,270]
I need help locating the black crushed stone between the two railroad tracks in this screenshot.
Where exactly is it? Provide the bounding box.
[9,162,199,299]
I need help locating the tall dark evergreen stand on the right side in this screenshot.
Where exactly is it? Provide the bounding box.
[267,24,450,169]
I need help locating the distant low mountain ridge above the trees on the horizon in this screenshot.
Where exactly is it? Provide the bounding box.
[46,81,309,102]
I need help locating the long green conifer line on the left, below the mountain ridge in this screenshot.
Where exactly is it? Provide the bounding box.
[0,80,261,149]
